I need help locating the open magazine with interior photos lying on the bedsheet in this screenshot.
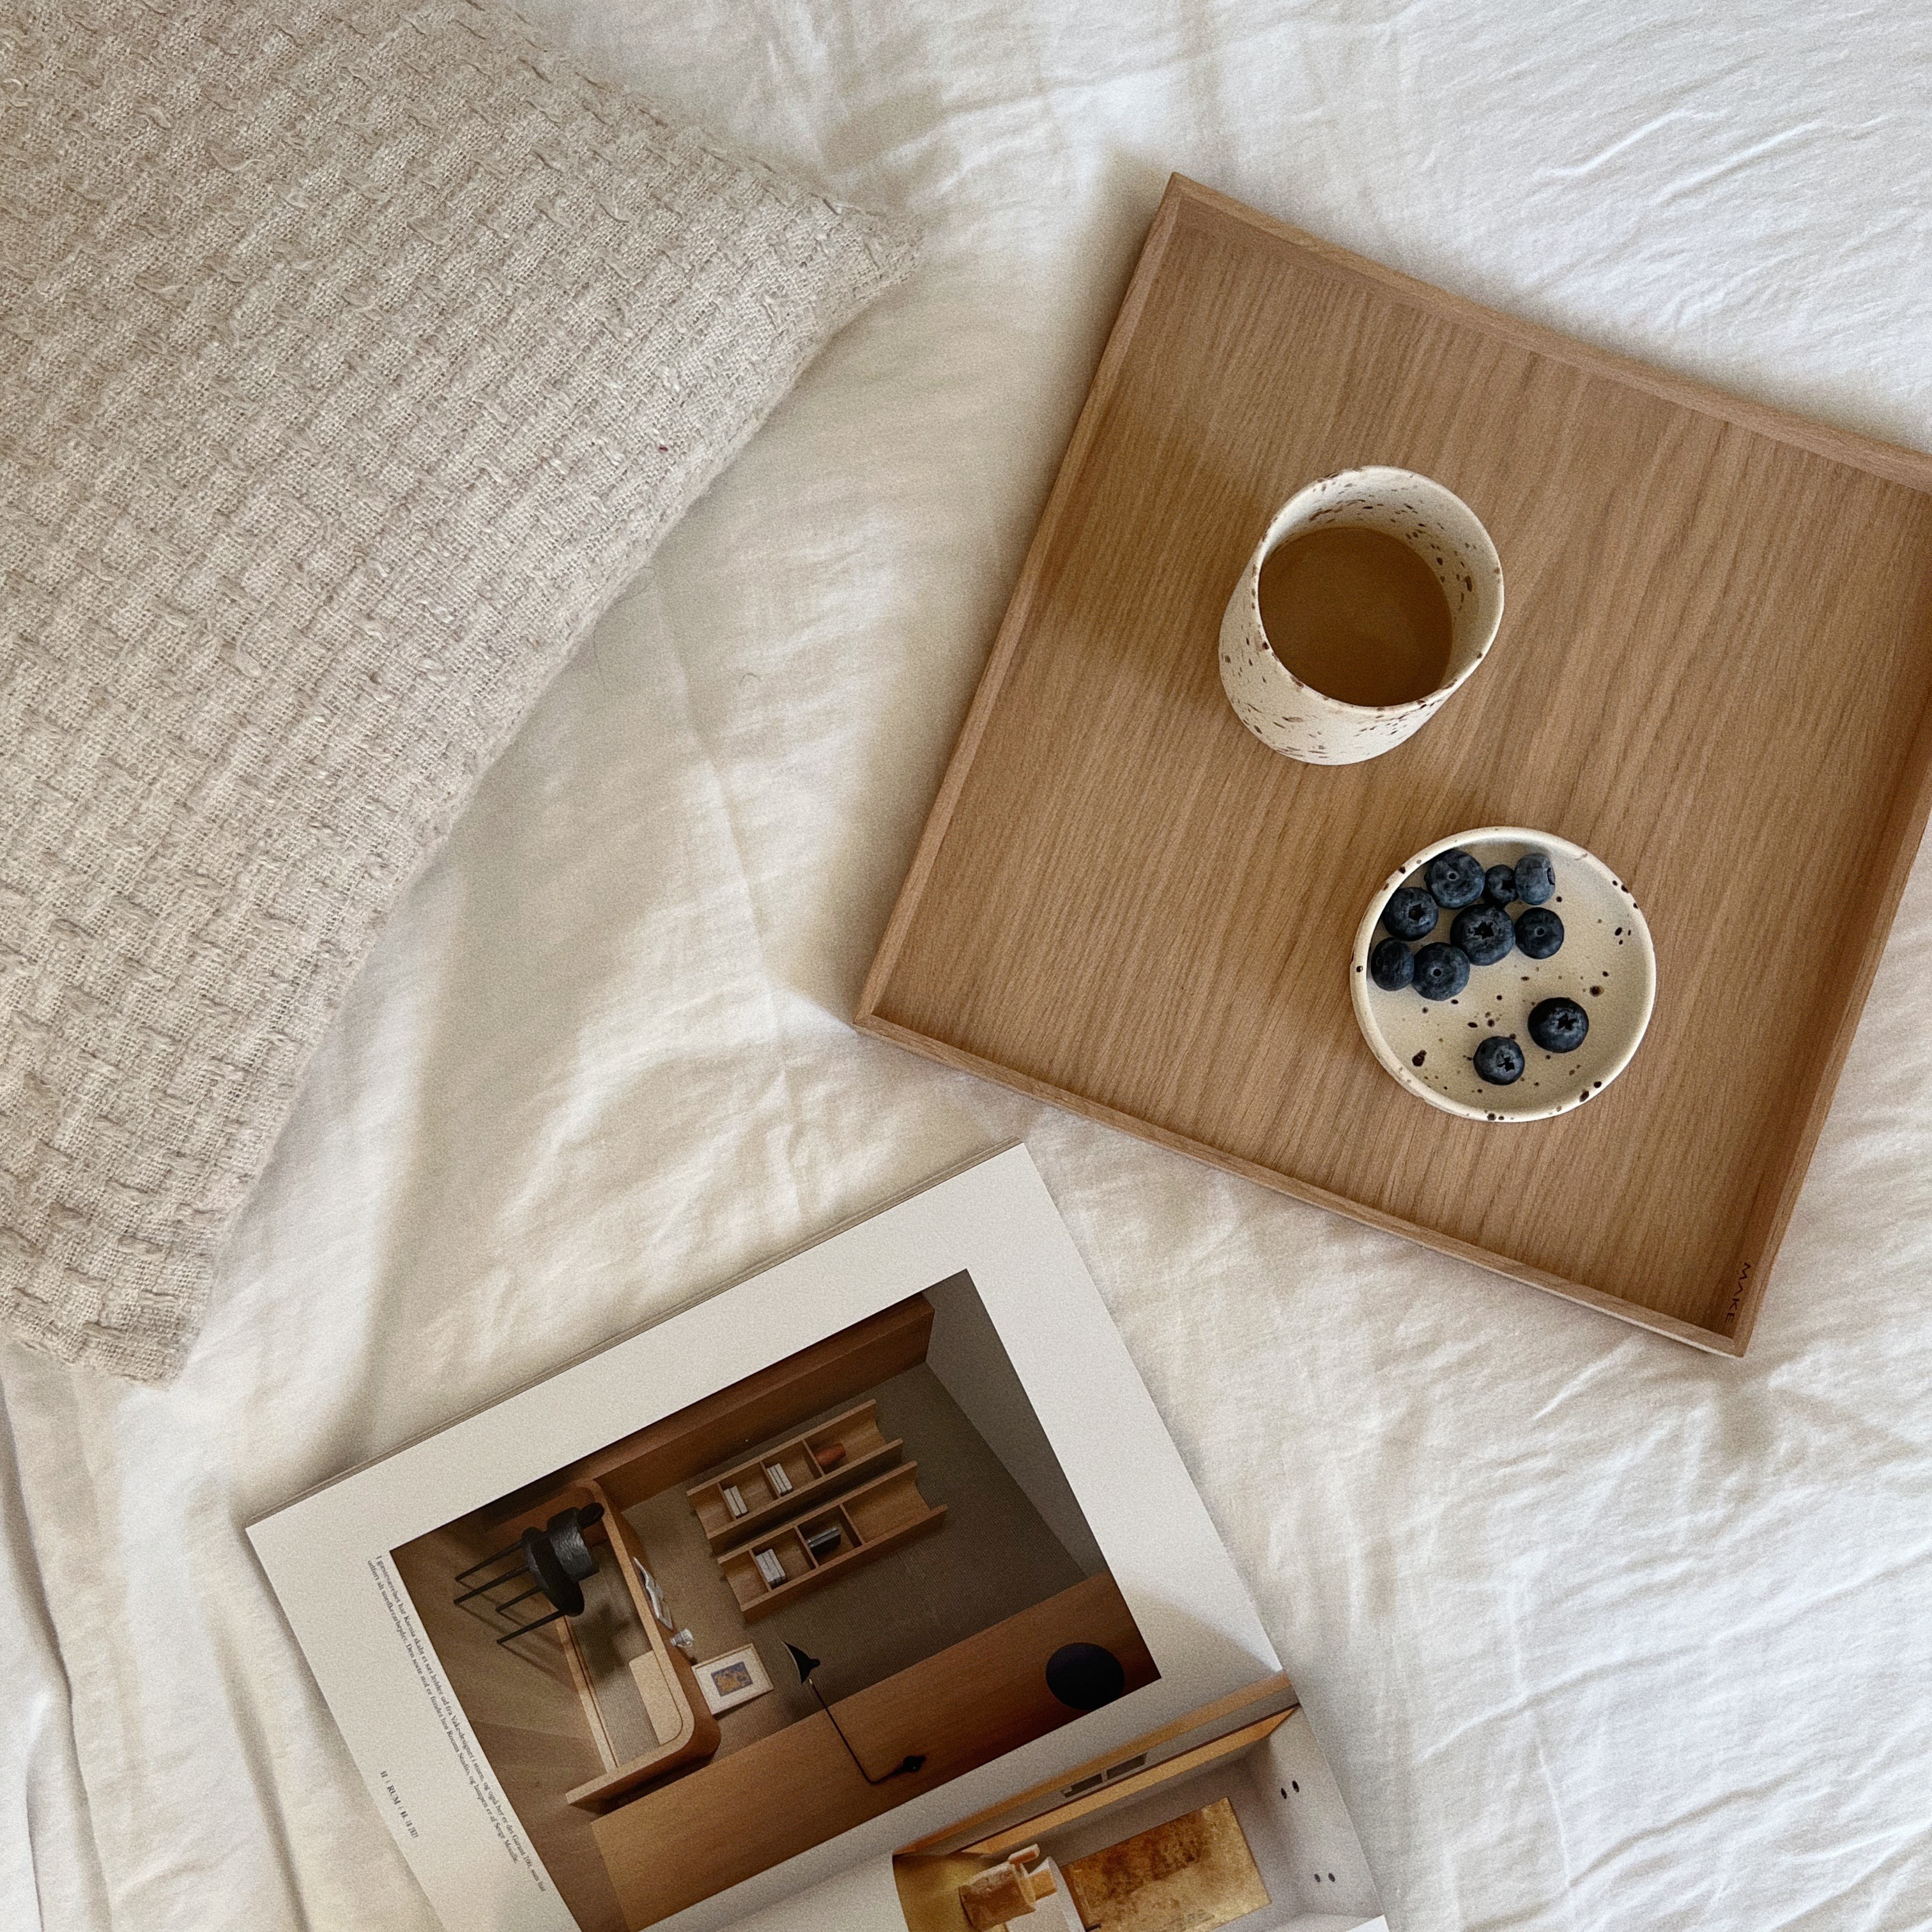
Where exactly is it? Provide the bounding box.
[249,1147,1381,1932]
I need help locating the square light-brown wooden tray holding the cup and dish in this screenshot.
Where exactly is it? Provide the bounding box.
[858,176,1932,1354]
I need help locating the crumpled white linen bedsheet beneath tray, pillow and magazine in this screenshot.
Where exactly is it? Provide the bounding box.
[0,0,1932,1932]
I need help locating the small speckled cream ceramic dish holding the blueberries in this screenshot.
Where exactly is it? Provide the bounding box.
[1349,825,1658,1121]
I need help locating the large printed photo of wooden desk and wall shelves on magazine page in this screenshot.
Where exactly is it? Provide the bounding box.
[390,1275,1157,1932]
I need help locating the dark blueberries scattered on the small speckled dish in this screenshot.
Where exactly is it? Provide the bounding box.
[1368,847,1590,1085]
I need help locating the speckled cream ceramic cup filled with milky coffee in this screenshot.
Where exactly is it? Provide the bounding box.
[1221,468,1503,765]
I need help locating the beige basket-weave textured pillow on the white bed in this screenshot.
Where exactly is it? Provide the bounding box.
[0,0,912,1381]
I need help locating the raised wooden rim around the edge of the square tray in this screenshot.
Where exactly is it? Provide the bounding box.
[852,172,1932,1356]
